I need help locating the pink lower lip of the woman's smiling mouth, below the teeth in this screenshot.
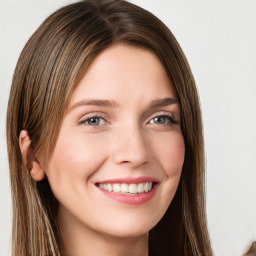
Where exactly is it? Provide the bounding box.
[99,184,157,205]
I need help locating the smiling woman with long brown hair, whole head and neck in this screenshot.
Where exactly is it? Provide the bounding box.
[7,0,212,256]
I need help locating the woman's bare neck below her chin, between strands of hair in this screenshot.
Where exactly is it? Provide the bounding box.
[58,208,148,256]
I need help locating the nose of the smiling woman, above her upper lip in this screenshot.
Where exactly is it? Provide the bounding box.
[112,124,150,168]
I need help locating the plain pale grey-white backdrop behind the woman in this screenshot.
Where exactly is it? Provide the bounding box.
[0,0,256,256]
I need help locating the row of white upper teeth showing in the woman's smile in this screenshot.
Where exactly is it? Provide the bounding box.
[99,182,153,195]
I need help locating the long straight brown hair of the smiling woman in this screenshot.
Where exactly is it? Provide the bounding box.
[7,0,212,256]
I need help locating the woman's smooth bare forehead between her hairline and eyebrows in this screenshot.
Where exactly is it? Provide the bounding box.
[68,44,175,103]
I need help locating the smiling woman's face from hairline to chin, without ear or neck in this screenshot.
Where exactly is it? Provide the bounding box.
[45,45,185,237]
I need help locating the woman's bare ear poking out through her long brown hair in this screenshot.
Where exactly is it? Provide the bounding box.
[19,130,45,181]
